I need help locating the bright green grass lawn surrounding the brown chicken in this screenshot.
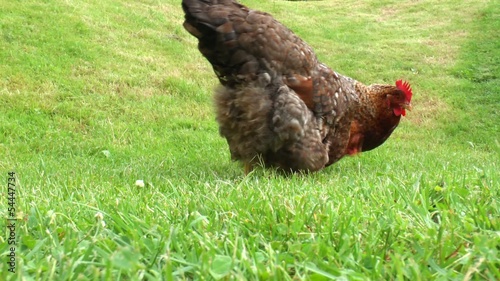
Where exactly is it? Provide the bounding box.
[0,0,500,280]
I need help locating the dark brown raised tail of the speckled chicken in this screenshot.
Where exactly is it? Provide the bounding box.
[182,0,259,86]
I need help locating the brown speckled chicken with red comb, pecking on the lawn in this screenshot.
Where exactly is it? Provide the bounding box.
[182,0,411,172]
